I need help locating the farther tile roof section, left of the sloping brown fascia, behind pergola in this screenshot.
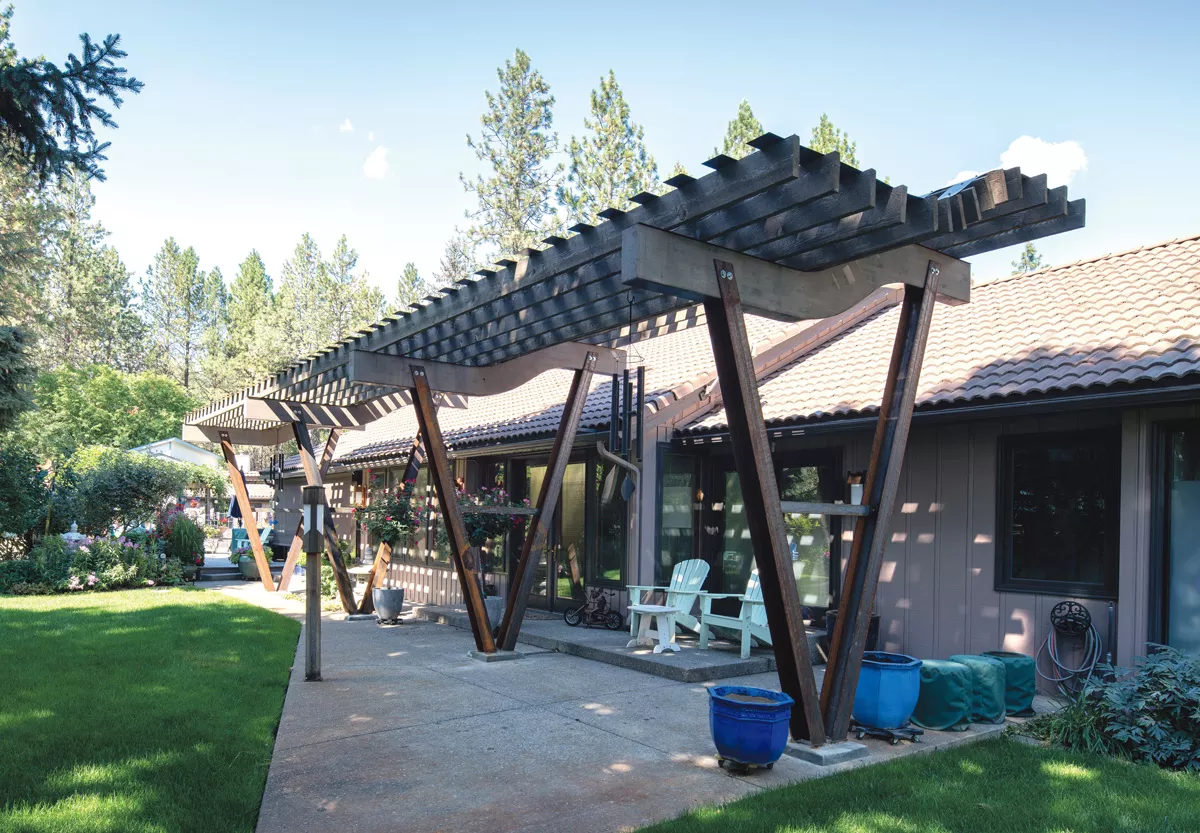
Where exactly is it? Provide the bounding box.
[324,316,811,468]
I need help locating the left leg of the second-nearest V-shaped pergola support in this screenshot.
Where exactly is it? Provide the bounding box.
[412,365,496,654]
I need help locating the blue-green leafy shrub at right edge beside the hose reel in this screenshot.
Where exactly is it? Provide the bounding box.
[1024,646,1200,772]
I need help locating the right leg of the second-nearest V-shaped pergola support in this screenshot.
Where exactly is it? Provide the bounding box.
[498,350,599,651]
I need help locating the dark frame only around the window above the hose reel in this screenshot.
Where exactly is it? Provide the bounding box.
[994,427,1121,601]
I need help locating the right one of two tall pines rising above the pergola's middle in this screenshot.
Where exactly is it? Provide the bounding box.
[558,70,659,226]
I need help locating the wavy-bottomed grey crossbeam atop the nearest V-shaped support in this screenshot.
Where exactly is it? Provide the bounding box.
[622,226,971,320]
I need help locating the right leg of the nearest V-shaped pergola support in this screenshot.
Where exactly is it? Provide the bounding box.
[821,260,941,741]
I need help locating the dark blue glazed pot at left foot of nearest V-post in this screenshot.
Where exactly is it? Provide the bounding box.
[708,685,794,767]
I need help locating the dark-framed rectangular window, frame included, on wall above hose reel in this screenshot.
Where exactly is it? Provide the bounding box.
[996,431,1121,598]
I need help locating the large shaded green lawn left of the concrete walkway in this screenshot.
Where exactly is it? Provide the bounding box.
[0,589,300,833]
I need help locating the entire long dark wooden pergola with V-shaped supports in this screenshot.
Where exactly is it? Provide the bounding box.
[184,133,1085,745]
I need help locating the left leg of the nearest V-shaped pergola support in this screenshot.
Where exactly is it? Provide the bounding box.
[704,259,824,747]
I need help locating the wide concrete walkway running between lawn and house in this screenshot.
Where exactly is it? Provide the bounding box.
[211,583,1036,833]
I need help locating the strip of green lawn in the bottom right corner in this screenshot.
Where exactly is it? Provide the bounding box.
[642,739,1200,833]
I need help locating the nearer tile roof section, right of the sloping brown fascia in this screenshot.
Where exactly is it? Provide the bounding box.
[684,235,1200,433]
